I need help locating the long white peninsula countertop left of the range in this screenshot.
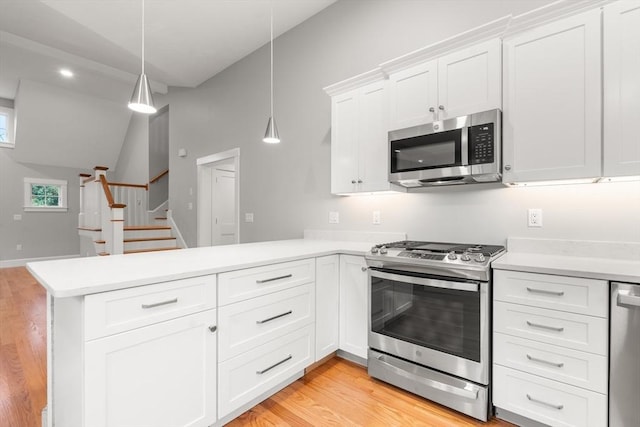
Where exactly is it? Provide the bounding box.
[27,239,371,298]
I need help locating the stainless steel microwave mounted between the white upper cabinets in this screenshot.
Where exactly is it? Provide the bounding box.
[389,109,502,188]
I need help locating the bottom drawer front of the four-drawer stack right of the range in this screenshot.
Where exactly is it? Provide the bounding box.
[493,366,607,427]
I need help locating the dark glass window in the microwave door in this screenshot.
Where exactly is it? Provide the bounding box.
[391,129,462,173]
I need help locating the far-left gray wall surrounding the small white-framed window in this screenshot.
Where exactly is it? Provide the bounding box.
[0,148,82,262]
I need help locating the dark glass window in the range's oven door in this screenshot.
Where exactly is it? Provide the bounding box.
[371,277,480,362]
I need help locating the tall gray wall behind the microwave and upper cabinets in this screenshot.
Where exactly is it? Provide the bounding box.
[168,0,640,246]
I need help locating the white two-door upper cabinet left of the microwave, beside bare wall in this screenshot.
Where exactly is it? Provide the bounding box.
[325,76,394,194]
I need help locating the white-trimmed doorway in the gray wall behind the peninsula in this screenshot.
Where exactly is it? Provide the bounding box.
[196,148,240,246]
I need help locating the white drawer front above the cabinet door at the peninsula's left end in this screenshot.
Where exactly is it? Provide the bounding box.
[84,275,216,340]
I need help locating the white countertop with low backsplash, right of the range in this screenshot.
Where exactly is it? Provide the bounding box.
[491,238,640,283]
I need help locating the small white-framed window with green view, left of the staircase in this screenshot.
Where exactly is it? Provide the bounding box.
[24,178,67,212]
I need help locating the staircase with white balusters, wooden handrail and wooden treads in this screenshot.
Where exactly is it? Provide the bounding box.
[78,166,182,256]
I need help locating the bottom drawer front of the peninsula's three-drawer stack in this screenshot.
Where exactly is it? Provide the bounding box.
[218,325,315,419]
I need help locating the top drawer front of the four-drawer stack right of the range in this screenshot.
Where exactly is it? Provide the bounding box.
[493,270,609,317]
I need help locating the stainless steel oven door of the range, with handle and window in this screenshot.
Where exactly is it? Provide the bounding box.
[369,268,489,385]
